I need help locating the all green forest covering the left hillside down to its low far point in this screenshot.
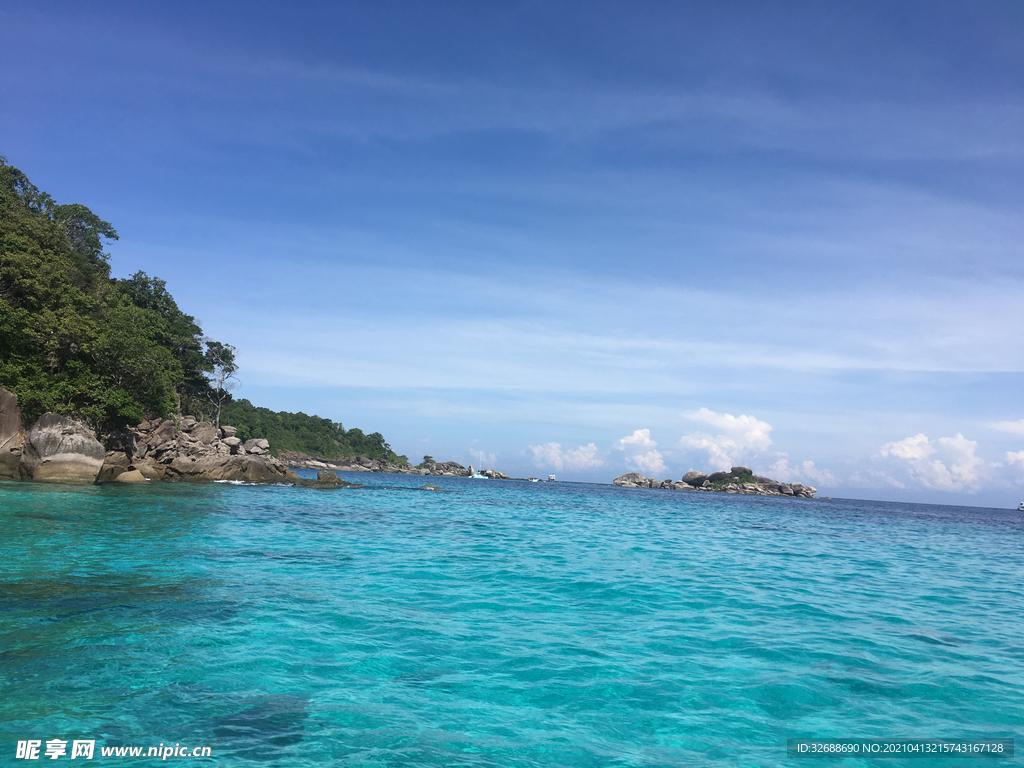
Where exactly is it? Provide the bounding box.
[0,156,404,461]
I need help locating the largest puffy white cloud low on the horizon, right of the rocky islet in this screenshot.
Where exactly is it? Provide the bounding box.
[881,434,990,492]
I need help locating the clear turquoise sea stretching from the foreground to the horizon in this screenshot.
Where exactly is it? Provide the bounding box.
[0,475,1024,768]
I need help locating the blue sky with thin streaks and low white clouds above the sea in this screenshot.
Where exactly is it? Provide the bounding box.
[0,2,1024,507]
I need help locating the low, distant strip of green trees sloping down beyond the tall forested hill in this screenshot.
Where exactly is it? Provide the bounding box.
[220,399,409,464]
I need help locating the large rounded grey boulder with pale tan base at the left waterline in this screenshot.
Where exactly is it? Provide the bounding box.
[20,414,106,485]
